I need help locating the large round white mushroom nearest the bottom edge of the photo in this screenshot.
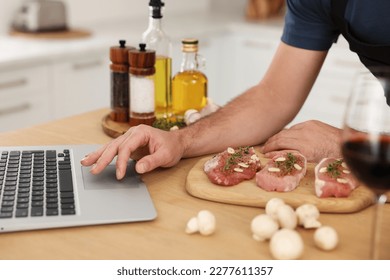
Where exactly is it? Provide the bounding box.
[270,228,303,260]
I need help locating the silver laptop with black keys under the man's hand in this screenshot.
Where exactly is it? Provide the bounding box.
[0,145,157,233]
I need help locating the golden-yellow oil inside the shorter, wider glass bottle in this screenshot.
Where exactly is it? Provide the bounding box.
[172,70,207,118]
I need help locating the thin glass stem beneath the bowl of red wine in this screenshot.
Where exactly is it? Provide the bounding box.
[371,194,387,260]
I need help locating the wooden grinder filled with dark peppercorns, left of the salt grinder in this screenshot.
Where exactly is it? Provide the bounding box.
[110,40,134,122]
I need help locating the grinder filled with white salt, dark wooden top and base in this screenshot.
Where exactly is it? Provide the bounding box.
[129,44,156,126]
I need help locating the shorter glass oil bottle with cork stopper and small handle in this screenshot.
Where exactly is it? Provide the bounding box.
[172,39,208,119]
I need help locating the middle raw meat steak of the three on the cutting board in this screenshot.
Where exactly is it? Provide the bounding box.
[256,151,307,192]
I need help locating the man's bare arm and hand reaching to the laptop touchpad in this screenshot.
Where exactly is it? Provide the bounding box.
[82,43,327,178]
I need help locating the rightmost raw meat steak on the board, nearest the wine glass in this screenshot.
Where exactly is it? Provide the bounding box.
[314,158,358,197]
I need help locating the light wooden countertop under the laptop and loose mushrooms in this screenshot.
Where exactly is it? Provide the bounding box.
[0,109,390,260]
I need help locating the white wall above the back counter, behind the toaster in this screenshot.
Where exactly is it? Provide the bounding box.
[0,0,212,35]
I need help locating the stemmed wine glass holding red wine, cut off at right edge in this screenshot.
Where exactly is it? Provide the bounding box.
[342,67,390,259]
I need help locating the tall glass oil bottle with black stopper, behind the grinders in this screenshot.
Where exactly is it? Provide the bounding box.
[142,0,172,118]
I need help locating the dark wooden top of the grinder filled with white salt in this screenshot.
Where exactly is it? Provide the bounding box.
[129,44,156,76]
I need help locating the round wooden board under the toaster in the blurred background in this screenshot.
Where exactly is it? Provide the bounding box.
[9,29,91,39]
